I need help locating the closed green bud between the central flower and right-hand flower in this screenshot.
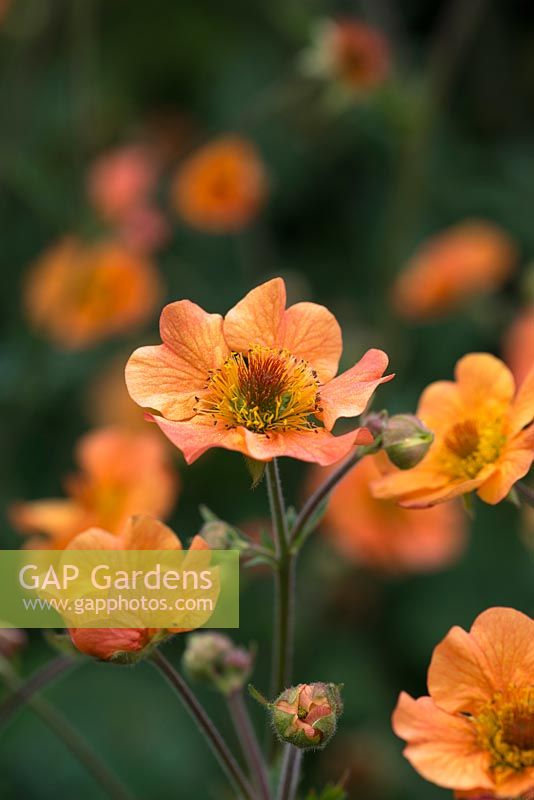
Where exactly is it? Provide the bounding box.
[364,411,434,469]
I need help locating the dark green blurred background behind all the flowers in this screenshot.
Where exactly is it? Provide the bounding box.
[0,0,534,800]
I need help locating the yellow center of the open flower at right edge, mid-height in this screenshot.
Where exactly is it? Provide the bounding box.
[442,415,506,479]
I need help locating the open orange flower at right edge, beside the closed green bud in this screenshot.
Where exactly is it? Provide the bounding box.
[372,353,534,507]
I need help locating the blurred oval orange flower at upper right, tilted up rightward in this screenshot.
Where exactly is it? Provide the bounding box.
[393,221,517,320]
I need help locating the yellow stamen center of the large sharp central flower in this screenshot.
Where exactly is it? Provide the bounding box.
[196,345,321,434]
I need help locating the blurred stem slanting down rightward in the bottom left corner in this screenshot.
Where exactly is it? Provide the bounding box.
[1,663,133,800]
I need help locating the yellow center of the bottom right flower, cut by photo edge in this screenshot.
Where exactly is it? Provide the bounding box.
[474,686,534,784]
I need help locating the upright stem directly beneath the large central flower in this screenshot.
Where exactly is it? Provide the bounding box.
[265,459,296,696]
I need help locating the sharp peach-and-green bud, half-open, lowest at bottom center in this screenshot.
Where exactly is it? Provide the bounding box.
[271,682,343,750]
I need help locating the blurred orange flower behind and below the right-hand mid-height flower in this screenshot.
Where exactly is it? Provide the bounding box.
[311,455,466,573]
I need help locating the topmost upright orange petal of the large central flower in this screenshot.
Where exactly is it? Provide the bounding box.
[224,278,286,352]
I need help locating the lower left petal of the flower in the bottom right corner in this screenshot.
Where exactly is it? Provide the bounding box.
[393,692,493,789]
